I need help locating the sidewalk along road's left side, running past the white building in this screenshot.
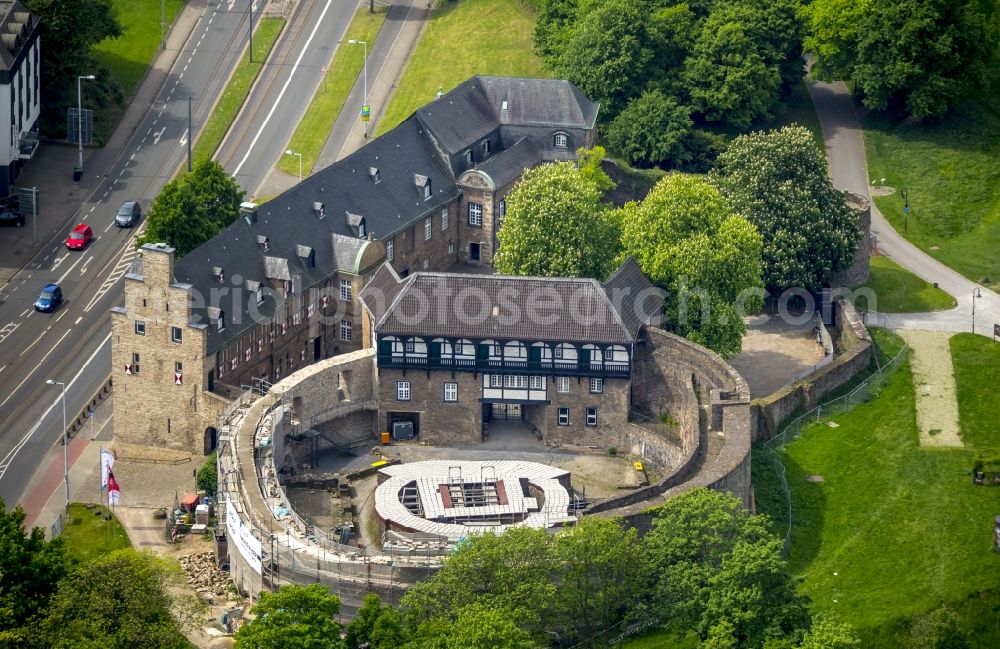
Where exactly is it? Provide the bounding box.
[0,0,208,290]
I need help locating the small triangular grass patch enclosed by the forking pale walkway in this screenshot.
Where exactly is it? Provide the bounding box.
[855,257,955,313]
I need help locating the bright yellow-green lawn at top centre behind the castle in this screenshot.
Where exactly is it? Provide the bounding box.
[375,0,550,135]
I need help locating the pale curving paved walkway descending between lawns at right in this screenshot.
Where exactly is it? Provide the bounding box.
[806,80,1000,336]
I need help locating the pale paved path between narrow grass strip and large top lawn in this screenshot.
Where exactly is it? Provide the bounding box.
[257,0,430,196]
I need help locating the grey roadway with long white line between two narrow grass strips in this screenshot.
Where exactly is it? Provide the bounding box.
[215,0,363,196]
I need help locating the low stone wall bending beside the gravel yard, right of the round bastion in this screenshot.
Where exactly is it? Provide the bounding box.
[753,298,873,440]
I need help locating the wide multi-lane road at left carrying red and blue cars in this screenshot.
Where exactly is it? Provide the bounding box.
[0,0,256,505]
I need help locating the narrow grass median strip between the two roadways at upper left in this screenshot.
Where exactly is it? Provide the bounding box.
[191,18,285,163]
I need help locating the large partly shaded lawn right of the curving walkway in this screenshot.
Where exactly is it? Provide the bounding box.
[864,74,1000,289]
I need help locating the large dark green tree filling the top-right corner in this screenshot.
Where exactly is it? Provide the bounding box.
[804,0,1000,119]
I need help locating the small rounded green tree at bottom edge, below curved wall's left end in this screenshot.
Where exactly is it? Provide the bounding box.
[233,584,347,649]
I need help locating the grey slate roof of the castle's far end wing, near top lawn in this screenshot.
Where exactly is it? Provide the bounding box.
[414,76,598,154]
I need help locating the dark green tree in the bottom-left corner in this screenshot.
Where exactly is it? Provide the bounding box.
[0,499,67,646]
